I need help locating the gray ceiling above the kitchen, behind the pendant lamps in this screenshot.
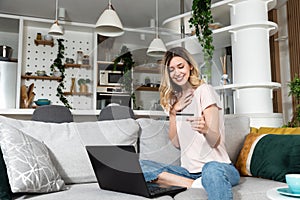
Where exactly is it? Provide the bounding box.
[0,0,192,28]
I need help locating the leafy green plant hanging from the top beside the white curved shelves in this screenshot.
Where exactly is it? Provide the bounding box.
[189,0,214,65]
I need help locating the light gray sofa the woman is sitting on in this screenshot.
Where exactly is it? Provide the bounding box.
[0,116,286,200]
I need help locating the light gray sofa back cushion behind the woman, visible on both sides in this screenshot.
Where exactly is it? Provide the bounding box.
[137,115,250,165]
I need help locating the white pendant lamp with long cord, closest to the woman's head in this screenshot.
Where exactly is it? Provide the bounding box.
[147,0,167,57]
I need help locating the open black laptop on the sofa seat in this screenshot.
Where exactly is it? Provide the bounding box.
[86,145,186,198]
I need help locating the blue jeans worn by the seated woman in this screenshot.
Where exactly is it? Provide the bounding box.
[140,160,240,200]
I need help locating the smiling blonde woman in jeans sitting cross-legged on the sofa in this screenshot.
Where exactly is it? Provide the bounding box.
[141,47,240,200]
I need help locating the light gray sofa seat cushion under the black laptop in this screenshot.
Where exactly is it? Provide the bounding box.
[14,183,172,200]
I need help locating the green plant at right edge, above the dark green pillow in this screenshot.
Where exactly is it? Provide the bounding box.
[288,75,300,127]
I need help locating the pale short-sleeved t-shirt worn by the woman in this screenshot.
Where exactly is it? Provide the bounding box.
[176,84,231,173]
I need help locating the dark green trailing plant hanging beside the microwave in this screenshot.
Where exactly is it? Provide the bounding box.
[114,46,136,107]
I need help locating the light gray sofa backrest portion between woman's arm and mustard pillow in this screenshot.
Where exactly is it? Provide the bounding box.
[224,115,250,163]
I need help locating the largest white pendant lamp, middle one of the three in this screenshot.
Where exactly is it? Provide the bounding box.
[96,0,124,37]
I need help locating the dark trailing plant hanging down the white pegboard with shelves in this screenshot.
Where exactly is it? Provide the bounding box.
[50,39,72,109]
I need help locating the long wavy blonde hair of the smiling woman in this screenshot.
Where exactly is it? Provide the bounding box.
[159,47,203,112]
